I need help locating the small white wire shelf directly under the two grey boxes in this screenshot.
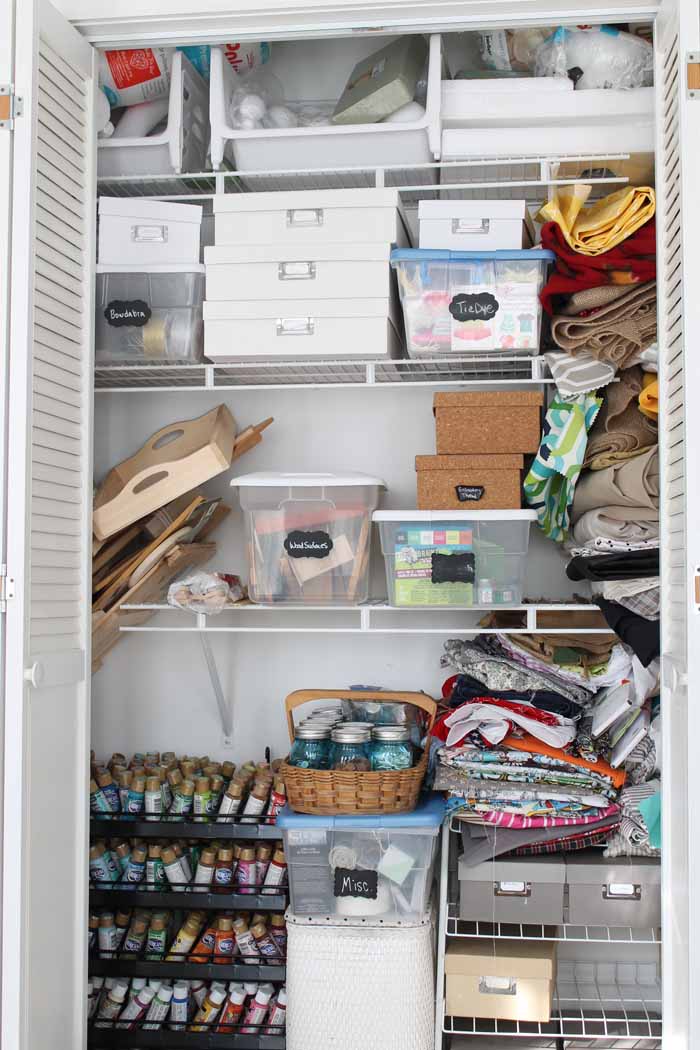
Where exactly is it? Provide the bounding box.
[446,903,661,944]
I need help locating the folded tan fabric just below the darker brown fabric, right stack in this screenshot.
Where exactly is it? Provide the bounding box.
[571,446,659,522]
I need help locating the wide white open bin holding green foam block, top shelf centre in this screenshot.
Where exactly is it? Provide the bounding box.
[210,35,442,180]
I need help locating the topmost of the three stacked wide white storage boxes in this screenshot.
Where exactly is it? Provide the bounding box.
[214,189,410,251]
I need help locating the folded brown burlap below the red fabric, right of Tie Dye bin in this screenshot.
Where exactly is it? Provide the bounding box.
[552,280,656,369]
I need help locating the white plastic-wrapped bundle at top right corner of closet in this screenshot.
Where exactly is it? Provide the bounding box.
[534,25,654,90]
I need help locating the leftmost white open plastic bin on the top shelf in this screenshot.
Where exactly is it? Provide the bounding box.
[98,51,209,179]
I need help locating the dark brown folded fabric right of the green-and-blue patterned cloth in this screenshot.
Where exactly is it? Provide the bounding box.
[584,365,658,470]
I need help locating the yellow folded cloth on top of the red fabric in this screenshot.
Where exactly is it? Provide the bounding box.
[537,183,656,255]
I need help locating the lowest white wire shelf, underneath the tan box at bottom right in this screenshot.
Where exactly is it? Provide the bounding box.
[443,966,661,1050]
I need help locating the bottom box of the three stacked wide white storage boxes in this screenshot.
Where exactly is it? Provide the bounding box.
[204,296,403,362]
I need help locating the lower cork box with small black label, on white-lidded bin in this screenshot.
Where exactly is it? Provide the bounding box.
[416,453,525,510]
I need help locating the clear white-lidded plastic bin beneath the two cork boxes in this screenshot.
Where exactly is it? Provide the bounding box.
[373,510,536,608]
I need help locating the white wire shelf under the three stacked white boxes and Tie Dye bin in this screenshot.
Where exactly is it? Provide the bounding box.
[94,354,553,393]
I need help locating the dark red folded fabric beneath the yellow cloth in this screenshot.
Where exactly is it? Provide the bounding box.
[539,218,656,314]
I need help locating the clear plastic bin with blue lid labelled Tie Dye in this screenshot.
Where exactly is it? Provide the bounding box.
[391,248,554,357]
